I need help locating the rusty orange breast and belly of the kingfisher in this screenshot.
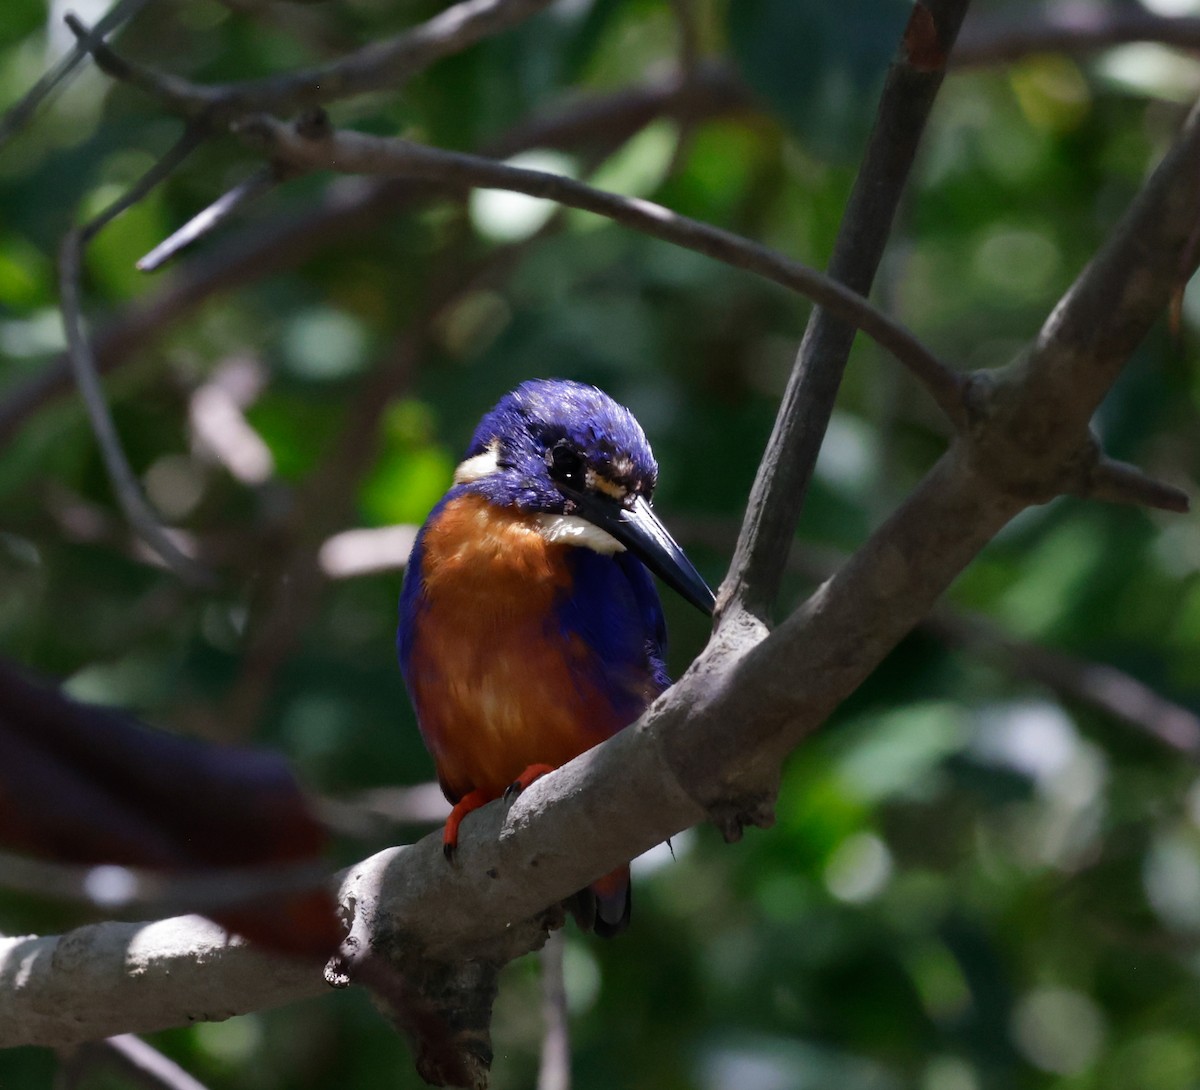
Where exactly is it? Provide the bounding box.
[409,496,625,799]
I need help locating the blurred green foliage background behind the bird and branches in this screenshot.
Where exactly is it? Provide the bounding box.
[0,0,1200,1090]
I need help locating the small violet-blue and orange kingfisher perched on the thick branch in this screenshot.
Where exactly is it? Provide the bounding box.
[396,379,714,936]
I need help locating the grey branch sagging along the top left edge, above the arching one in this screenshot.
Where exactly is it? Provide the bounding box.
[72,0,561,125]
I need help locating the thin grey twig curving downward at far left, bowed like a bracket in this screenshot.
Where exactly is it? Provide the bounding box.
[59,126,212,586]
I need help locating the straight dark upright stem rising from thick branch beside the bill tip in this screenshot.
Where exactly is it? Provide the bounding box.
[718,0,970,618]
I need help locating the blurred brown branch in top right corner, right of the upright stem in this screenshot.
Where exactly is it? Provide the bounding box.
[950,4,1200,70]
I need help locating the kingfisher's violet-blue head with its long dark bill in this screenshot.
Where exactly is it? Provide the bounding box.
[455,378,713,612]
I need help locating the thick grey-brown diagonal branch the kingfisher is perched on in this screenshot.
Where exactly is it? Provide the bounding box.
[0,6,1200,1080]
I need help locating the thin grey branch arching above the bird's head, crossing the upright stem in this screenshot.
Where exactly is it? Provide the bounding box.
[231,115,964,423]
